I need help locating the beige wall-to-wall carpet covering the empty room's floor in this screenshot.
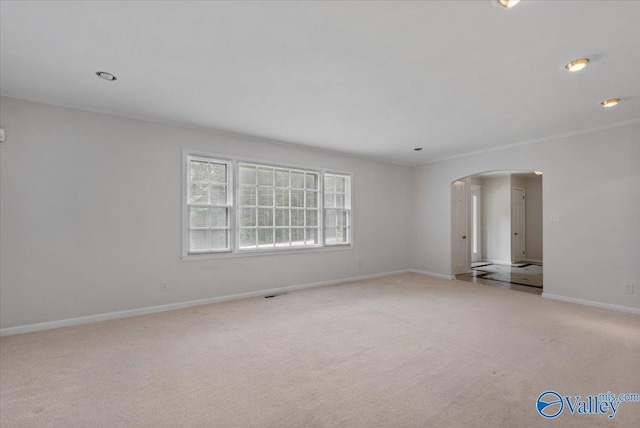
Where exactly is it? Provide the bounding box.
[0,274,640,428]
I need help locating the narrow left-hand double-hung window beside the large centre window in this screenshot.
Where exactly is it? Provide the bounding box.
[187,156,232,254]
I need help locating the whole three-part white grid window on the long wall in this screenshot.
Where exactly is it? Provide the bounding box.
[182,150,352,259]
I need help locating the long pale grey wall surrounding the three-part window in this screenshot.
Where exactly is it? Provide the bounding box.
[0,98,410,328]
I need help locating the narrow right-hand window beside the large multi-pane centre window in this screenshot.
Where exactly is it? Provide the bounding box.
[324,174,351,245]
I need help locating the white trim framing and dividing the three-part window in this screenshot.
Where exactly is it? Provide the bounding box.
[181,149,355,261]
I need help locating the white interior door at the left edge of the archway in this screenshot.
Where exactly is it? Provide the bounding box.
[451,180,471,275]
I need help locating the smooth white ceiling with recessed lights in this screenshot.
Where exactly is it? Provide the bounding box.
[0,0,640,165]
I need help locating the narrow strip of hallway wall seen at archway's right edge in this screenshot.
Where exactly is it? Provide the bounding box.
[524,176,543,262]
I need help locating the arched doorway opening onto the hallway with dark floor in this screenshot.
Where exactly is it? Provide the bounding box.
[451,170,543,294]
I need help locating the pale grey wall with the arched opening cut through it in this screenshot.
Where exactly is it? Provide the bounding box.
[411,120,640,309]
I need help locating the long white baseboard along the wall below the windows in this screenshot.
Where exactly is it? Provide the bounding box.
[0,269,409,336]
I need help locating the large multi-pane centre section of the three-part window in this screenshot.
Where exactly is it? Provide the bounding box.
[238,162,320,250]
